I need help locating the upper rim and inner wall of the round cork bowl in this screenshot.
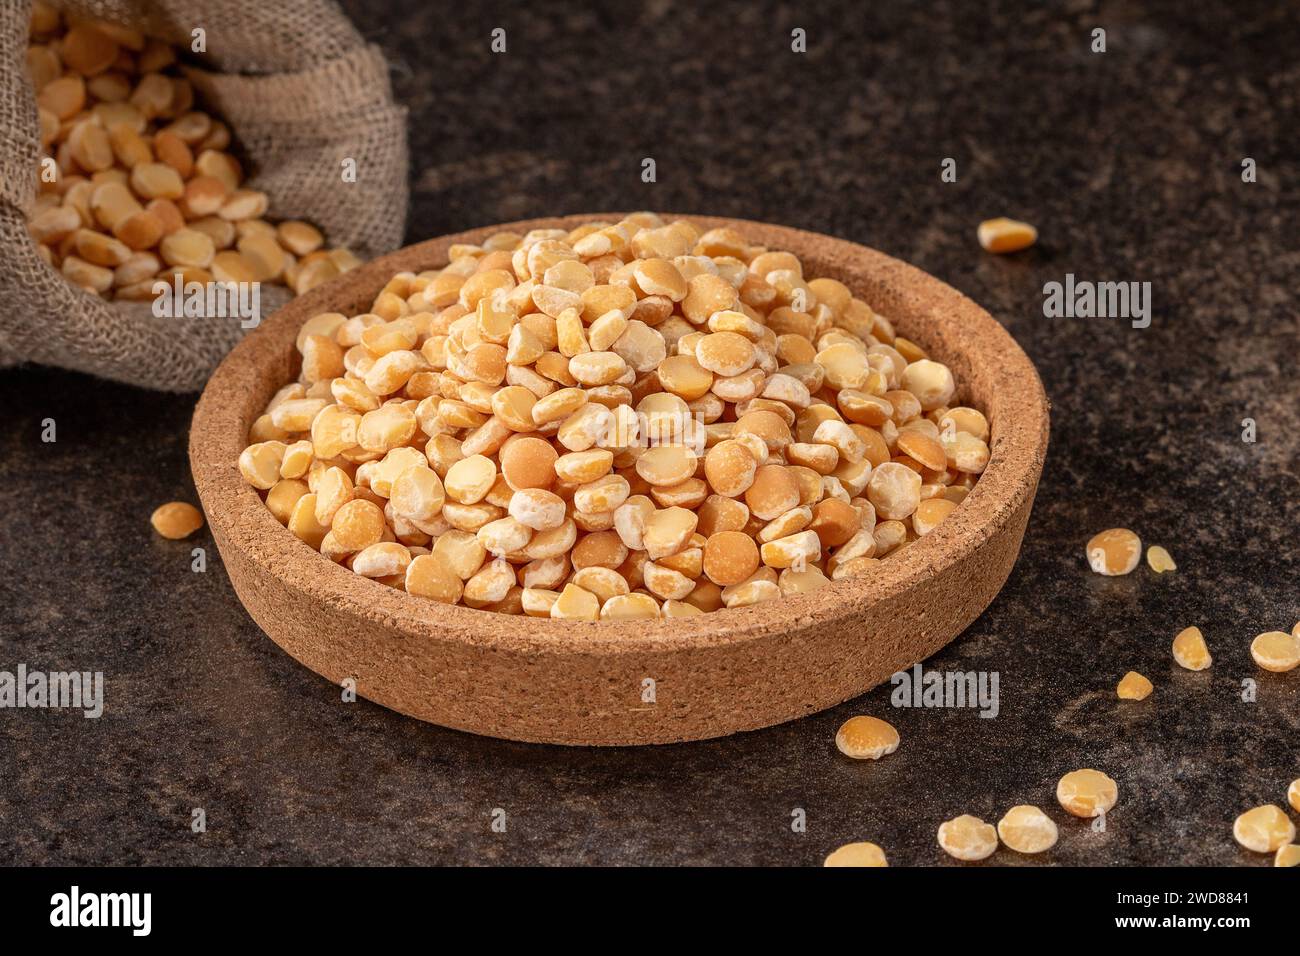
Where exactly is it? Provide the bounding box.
[190,212,1049,656]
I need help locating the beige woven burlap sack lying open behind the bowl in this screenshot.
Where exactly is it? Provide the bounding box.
[0,0,407,392]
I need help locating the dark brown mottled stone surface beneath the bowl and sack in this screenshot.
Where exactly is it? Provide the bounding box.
[0,0,1300,865]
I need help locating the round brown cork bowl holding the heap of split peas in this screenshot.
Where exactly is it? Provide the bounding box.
[190,213,1048,745]
